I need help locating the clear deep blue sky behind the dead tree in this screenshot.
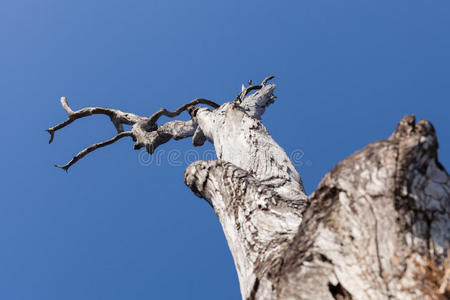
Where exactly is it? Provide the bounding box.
[0,0,450,300]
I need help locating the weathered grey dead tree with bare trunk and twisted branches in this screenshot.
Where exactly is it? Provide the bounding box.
[47,77,450,300]
